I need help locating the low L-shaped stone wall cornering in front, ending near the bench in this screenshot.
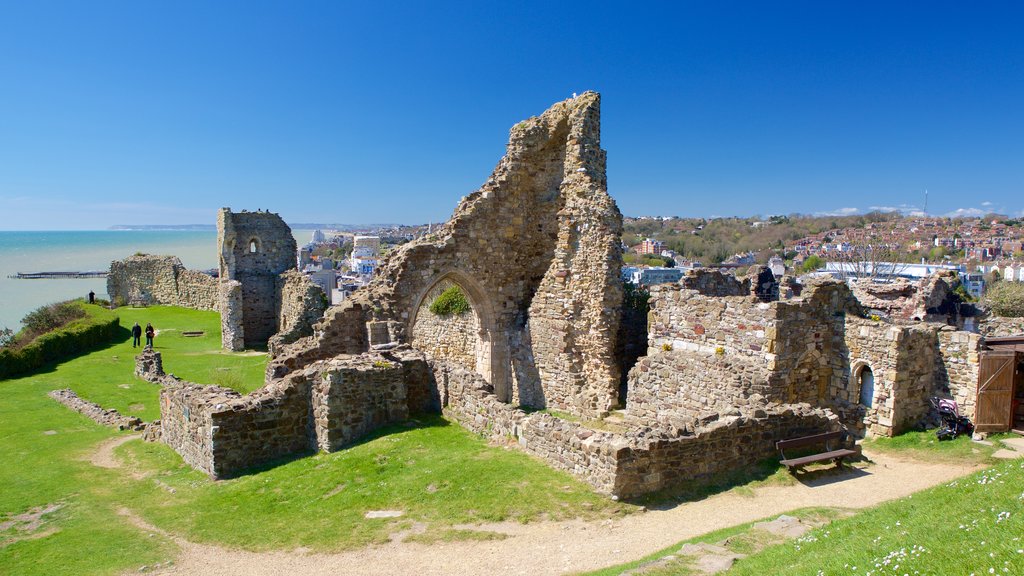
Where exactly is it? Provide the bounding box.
[432,363,842,498]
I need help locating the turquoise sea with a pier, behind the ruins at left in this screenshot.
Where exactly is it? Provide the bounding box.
[0,230,312,331]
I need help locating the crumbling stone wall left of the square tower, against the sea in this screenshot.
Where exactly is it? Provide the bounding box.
[106,254,217,310]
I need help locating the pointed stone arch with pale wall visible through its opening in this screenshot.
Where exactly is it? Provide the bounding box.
[406,270,512,402]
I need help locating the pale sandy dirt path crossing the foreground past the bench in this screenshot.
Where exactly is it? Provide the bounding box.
[123,454,974,576]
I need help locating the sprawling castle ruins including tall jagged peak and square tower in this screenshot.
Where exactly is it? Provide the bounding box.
[139,92,981,497]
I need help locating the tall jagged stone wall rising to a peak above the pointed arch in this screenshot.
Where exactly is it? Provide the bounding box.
[272,92,622,414]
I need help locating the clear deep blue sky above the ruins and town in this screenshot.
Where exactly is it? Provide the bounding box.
[0,0,1024,230]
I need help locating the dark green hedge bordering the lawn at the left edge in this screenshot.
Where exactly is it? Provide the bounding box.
[0,302,121,378]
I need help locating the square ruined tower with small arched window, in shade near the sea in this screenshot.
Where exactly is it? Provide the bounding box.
[217,208,296,347]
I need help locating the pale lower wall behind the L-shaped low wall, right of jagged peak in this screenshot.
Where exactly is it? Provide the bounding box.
[628,351,785,428]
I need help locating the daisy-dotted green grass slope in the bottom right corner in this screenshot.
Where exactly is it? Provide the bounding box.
[727,460,1024,576]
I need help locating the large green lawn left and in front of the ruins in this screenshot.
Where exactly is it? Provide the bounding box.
[0,307,634,575]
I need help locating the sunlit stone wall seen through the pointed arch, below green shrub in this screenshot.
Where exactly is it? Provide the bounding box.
[412,281,480,370]
